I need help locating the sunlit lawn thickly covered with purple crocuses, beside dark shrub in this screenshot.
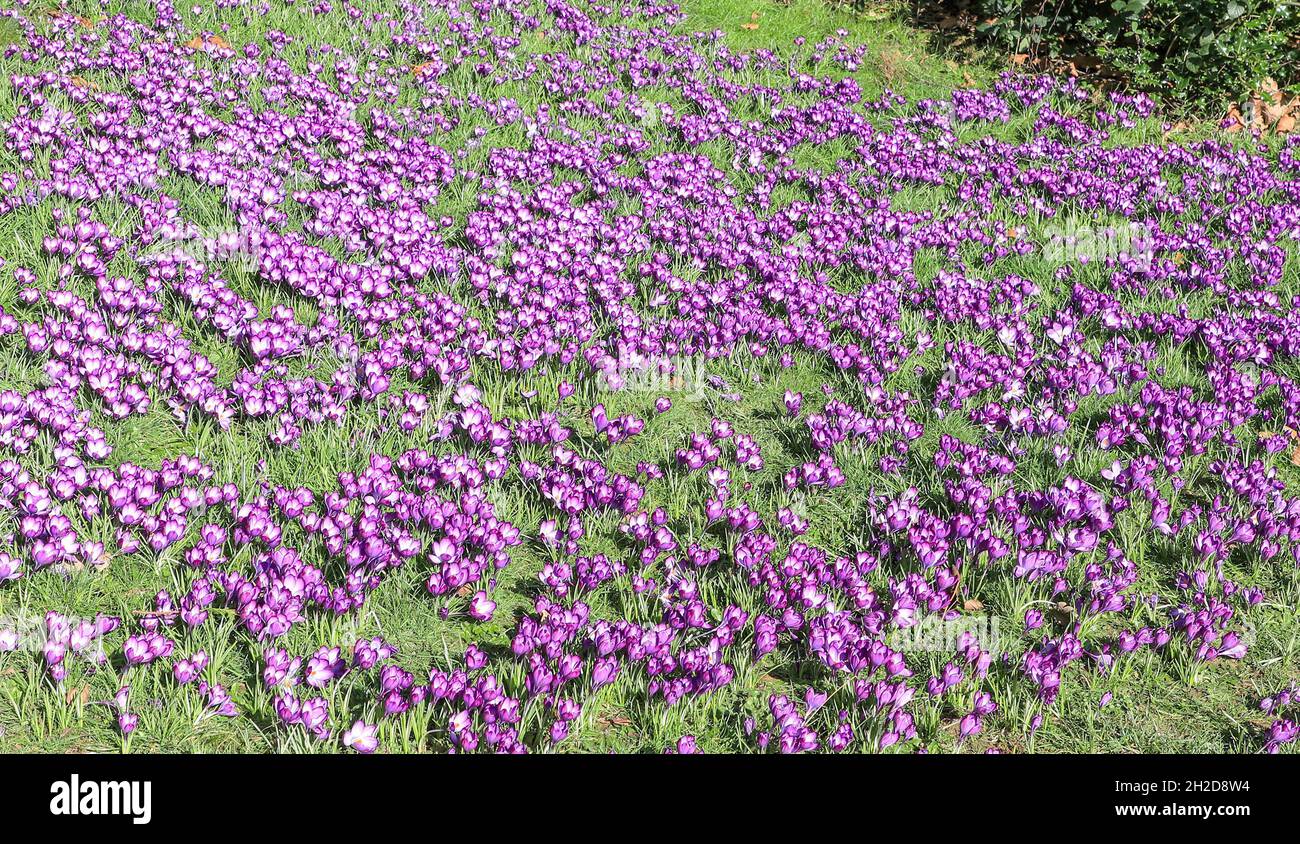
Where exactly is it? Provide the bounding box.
[0,0,1300,753]
